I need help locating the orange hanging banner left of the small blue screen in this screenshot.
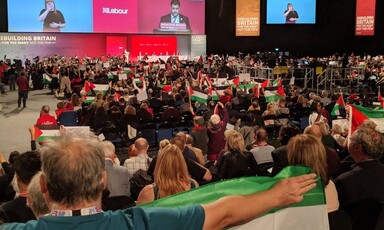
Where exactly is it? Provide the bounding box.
[236,0,260,36]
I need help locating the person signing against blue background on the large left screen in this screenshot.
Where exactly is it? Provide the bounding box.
[39,0,65,32]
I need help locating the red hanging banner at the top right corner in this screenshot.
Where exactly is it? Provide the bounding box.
[355,0,376,36]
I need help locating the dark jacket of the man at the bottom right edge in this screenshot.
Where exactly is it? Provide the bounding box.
[335,160,384,229]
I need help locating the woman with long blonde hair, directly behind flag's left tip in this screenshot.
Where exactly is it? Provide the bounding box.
[136,144,199,205]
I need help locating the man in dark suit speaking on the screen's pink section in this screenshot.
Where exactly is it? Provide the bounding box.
[160,0,191,30]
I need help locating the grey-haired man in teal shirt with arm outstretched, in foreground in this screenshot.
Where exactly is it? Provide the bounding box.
[1,134,316,230]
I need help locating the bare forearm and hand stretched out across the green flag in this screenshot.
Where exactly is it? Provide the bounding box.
[203,173,316,229]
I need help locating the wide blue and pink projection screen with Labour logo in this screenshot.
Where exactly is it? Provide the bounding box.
[8,0,205,34]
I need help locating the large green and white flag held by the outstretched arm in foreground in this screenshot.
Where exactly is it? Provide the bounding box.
[141,166,329,230]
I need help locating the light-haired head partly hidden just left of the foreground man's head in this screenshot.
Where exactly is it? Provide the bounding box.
[27,171,49,219]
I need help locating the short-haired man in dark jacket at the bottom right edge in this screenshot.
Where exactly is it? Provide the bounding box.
[335,128,384,229]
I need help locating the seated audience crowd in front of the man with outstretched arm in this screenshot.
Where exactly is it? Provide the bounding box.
[0,53,384,229]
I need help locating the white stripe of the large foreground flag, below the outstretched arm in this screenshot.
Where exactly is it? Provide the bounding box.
[230,205,329,230]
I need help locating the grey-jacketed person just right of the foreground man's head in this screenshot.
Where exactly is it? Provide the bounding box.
[101,141,131,197]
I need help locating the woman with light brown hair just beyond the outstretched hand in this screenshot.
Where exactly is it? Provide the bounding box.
[287,134,339,213]
